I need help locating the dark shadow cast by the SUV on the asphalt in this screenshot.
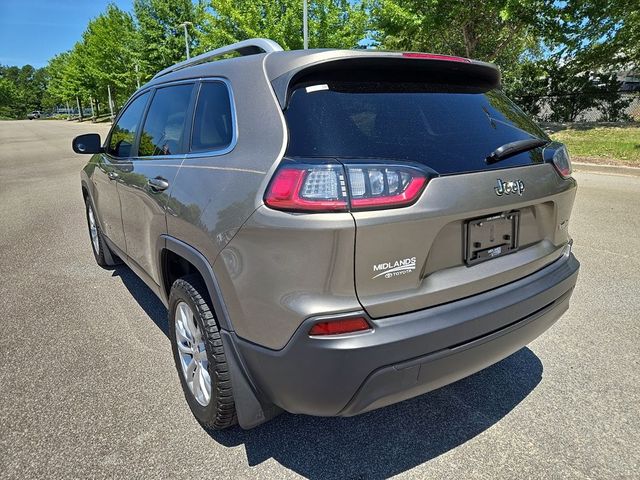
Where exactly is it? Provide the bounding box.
[113,266,543,479]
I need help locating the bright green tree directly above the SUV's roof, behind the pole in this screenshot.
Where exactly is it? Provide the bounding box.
[201,0,369,49]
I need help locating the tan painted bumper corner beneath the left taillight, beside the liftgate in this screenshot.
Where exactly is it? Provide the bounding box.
[214,206,361,350]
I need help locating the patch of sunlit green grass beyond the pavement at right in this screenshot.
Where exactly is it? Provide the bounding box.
[551,127,640,167]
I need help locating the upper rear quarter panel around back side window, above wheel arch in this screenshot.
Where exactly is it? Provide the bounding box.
[167,58,286,265]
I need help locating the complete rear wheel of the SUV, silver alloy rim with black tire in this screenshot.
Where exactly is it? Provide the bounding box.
[169,275,237,430]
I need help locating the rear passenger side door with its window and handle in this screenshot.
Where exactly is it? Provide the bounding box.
[118,82,194,285]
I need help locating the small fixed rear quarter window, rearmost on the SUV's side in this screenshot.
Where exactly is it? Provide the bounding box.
[191,82,233,152]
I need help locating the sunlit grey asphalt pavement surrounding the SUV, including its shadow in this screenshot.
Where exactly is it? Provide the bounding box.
[0,120,640,479]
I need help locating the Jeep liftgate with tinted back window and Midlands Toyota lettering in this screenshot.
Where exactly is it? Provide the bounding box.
[285,72,575,317]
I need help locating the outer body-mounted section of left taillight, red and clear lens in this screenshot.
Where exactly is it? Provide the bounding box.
[264,165,347,212]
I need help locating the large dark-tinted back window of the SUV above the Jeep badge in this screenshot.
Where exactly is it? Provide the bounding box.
[285,82,547,175]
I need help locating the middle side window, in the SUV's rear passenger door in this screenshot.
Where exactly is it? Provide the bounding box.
[138,84,193,157]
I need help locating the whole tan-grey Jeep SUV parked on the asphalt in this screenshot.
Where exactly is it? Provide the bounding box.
[73,39,579,429]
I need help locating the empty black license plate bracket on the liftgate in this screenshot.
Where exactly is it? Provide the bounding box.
[464,210,520,266]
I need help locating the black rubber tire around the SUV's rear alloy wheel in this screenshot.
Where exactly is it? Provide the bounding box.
[169,275,238,430]
